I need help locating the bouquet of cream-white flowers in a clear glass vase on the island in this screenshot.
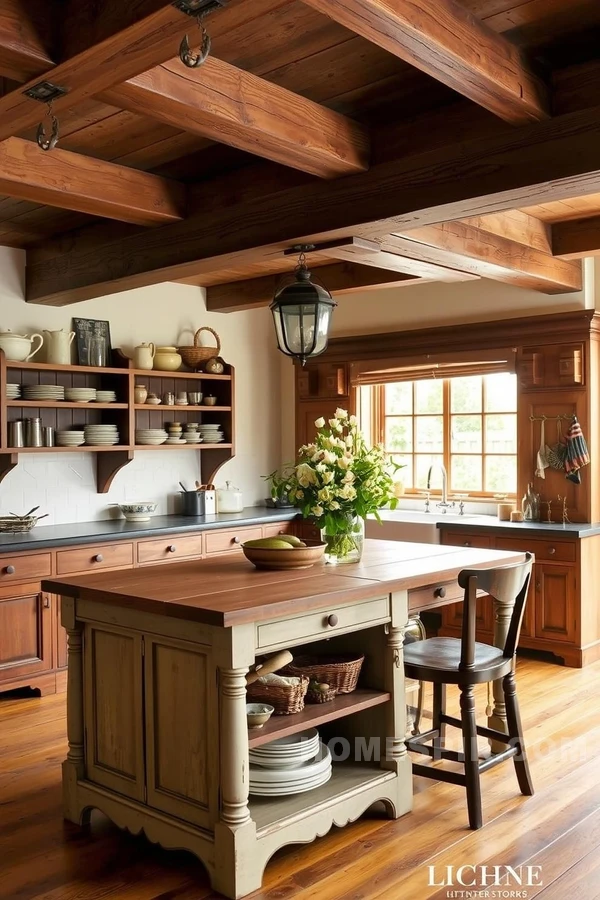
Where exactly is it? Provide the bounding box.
[289,409,402,557]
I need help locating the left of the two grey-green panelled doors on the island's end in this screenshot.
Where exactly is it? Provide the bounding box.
[83,623,145,801]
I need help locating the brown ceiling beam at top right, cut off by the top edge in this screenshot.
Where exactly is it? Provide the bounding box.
[304,0,550,124]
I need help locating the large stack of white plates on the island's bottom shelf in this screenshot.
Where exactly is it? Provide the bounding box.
[250,728,331,797]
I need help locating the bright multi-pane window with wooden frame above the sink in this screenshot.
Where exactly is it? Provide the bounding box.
[358,372,517,497]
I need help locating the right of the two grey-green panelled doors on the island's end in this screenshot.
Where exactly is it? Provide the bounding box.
[144,635,219,828]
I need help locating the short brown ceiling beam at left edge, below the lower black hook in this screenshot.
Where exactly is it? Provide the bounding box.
[0,138,186,225]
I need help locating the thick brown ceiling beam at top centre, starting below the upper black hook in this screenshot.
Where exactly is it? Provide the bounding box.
[99,57,369,178]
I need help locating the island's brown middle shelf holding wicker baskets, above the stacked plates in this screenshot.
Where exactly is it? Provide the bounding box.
[248,688,392,750]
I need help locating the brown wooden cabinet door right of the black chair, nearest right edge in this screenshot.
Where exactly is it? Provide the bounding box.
[535,563,578,643]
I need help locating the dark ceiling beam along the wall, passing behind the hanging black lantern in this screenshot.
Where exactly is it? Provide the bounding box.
[206,264,423,312]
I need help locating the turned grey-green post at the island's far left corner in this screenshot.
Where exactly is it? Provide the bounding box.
[61,597,89,825]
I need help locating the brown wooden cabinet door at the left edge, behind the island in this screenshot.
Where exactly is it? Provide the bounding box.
[0,585,52,684]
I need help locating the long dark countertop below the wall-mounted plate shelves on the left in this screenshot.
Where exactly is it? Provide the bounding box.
[0,506,298,555]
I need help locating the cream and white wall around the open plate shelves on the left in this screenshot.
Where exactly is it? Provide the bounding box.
[0,247,281,527]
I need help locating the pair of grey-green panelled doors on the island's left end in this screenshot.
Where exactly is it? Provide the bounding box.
[84,623,219,828]
